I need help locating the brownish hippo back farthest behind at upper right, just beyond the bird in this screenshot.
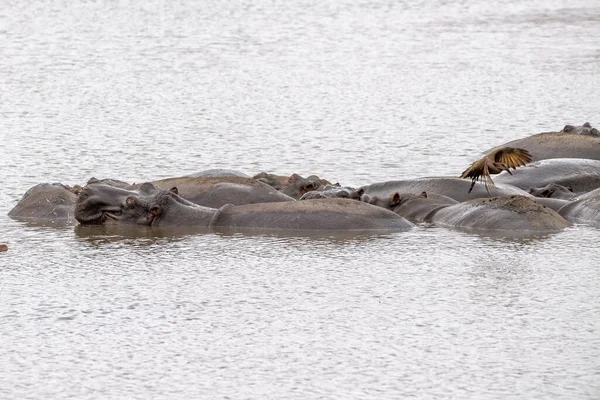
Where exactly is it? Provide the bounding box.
[486,122,600,161]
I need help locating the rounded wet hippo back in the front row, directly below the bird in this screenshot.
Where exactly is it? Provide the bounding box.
[425,196,571,233]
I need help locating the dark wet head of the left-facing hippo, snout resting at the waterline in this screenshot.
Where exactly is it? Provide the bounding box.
[75,183,169,225]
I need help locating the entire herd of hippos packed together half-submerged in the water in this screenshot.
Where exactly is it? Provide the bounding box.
[4,123,600,241]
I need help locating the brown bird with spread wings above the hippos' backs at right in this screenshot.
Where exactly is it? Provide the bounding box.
[460,147,533,193]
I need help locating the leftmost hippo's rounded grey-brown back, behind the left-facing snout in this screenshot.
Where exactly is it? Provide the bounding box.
[8,183,81,224]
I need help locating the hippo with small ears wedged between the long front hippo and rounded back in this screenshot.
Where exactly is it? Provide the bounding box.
[361,192,458,222]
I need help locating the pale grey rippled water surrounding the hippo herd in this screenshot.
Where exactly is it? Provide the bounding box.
[0,0,600,399]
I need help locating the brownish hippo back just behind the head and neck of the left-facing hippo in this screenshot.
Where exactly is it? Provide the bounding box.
[128,176,294,208]
